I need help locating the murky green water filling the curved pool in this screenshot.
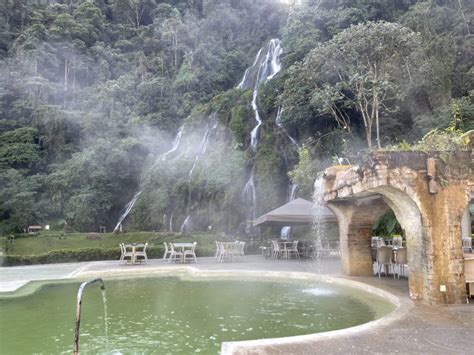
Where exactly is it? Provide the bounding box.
[0,277,394,354]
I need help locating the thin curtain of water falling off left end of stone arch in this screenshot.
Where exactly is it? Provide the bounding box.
[313,175,328,259]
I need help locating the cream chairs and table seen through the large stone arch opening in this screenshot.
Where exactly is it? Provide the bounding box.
[372,237,408,278]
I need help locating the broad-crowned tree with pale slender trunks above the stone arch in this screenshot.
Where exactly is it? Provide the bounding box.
[304,22,421,148]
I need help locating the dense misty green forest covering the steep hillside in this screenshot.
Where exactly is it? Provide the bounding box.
[0,0,474,234]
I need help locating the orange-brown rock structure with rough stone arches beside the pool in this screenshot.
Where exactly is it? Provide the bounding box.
[324,150,474,304]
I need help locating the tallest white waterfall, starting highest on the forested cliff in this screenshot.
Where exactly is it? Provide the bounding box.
[237,38,283,219]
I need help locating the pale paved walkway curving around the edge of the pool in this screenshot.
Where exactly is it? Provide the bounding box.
[0,256,474,355]
